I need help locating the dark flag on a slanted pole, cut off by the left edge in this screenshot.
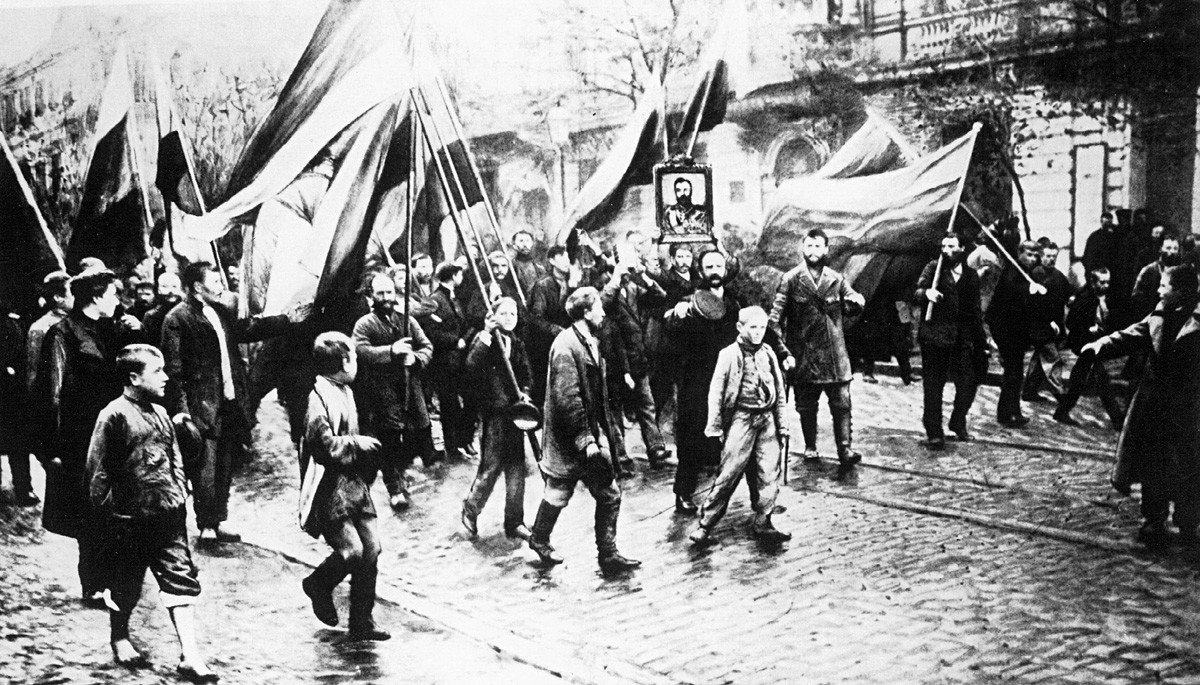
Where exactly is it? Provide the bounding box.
[0,133,65,316]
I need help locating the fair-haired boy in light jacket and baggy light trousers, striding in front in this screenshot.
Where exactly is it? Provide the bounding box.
[689,307,792,545]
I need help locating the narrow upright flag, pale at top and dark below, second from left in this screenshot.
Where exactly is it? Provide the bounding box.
[67,44,151,273]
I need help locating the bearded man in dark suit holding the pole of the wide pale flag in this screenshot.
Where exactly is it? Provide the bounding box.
[916,233,988,450]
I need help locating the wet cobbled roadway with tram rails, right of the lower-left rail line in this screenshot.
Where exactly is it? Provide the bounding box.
[220,379,1200,684]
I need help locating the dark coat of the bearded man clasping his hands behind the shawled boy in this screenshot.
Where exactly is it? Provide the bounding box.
[354,312,433,434]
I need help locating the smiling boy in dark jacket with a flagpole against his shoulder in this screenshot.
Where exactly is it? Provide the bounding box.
[462,298,533,540]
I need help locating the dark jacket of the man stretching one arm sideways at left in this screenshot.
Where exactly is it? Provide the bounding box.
[161,298,292,439]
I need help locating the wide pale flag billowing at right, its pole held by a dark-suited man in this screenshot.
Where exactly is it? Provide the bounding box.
[758,127,978,298]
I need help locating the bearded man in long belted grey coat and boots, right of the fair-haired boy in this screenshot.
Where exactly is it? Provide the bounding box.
[770,228,866,468]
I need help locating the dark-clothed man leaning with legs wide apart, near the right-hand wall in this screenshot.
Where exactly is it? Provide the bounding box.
[1054,269,1124,431]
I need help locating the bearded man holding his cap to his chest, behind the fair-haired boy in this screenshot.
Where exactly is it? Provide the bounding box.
[662,248,742,516]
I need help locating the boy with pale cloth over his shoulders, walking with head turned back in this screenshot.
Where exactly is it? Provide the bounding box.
[300,331,391,641]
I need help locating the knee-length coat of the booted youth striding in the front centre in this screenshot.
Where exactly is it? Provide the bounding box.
[539,328,611,479]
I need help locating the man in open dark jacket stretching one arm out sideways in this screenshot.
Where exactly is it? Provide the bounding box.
[161,262,304,542]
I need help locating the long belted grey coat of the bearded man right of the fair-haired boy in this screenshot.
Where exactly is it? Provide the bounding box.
[770,264,863,383]
